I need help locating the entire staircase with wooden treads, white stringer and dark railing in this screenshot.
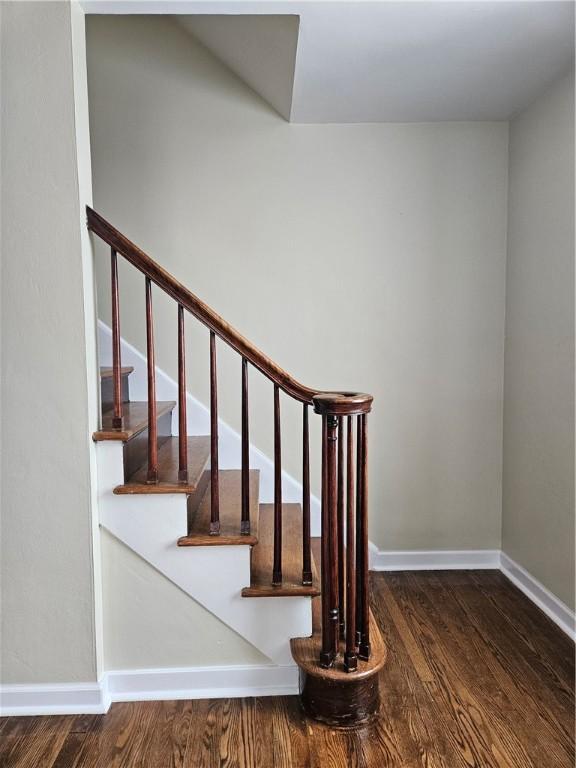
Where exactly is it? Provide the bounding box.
[87,208,386,725]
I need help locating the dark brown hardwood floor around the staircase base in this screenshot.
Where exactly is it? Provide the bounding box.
[0,571,574,768]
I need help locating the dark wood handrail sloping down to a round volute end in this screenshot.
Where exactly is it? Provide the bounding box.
[86,206,372,415]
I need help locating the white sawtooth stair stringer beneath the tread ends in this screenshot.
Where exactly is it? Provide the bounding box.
[96,441,312,666]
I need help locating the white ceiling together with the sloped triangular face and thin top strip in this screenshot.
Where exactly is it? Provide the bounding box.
[83,0,574,123]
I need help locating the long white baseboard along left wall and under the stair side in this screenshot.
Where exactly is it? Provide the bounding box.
[0,665,298,717]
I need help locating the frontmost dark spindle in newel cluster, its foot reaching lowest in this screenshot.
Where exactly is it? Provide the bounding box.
[344,416,358,672]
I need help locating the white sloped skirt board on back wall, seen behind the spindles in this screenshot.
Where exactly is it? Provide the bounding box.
[98,320,321,536]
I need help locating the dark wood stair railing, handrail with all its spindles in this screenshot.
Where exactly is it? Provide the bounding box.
[86,207,372,672]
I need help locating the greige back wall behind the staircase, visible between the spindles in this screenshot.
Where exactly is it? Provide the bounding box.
[87,17,508,550]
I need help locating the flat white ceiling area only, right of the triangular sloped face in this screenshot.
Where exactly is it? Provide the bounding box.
[292,2,574,123]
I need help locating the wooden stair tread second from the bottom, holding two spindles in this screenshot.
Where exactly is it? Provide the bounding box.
[242,504,320,597]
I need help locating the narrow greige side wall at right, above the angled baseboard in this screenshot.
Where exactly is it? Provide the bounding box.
[502,69,574,608]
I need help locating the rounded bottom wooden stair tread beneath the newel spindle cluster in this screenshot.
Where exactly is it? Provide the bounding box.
[290,600,386,683]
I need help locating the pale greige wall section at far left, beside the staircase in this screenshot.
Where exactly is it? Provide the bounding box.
[0,2,98,683]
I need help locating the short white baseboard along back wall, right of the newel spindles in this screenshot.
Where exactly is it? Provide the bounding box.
[370,544,500,571]
